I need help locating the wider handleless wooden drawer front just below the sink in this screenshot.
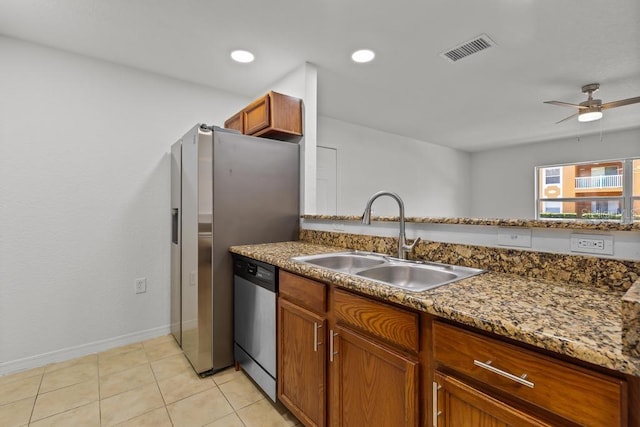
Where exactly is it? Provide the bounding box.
[333,289,419,352]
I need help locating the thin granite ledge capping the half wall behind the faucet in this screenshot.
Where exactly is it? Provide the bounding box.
[302,215,640,231]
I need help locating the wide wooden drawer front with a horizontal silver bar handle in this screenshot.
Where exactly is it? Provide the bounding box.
[433,322,627,426]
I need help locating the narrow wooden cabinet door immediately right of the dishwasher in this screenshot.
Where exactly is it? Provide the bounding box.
[278,298,326,427]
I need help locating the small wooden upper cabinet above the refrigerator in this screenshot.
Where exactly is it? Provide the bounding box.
[224,91,302,142]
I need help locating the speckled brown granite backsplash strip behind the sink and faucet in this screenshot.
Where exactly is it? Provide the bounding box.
[300,229,640,291]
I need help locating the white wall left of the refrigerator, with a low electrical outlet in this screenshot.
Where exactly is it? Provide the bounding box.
[0,37,251,375]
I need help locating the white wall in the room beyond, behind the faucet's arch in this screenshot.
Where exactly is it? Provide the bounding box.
[316,116,470,217]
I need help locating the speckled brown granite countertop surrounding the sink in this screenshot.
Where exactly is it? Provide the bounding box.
[230,242,640,376]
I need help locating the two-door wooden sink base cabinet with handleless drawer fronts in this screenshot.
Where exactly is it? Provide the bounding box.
[278,271,420,427]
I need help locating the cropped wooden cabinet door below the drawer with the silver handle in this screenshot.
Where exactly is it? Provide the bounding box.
[432,371,551,427]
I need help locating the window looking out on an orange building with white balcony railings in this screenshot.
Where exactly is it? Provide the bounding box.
[535,158,640,223]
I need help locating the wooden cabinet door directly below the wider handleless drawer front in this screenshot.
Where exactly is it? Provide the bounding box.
[329,327,419,427]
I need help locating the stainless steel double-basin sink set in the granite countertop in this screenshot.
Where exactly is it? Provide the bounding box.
[293,251,484,292]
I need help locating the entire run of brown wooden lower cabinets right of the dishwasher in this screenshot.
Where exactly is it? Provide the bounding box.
[277,271,640,427]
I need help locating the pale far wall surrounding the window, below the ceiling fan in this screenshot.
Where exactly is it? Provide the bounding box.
[471,128,640,218]
